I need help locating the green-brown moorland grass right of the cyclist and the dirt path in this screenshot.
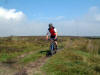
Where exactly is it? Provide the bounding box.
[42,38,100,75]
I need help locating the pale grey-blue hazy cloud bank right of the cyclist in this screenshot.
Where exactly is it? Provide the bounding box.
[55,7,100,36]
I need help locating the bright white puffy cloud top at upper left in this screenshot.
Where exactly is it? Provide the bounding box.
[0,7,25,20]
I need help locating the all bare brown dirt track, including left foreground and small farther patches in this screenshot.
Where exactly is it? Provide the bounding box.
[0,49,61,75]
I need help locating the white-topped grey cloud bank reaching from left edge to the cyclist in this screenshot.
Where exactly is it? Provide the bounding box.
[0,7,48,36]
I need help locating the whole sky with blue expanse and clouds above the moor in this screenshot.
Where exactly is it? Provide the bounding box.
[0,0,100,36]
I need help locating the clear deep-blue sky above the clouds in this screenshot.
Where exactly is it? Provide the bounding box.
[0,0,100,19]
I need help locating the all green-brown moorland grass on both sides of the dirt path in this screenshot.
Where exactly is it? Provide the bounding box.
[0,36,100,75]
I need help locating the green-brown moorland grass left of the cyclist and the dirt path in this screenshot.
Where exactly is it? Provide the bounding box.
[0,37,48,62]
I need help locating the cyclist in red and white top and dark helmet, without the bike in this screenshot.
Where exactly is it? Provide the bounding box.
[46,23,58,49]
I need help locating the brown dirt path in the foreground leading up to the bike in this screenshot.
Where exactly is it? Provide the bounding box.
[15,56,48,75]
